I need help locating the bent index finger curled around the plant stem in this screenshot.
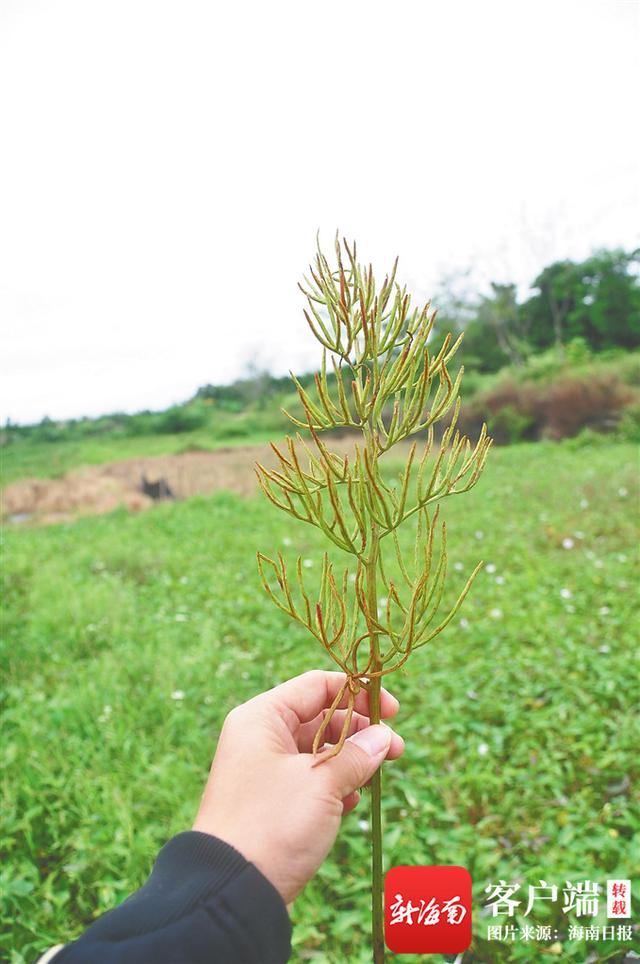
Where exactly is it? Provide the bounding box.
[264,669,400,723]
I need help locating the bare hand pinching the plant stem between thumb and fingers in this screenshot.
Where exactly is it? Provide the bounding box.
[193,670,404,904]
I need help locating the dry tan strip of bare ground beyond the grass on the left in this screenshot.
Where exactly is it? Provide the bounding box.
[2,438,368,525]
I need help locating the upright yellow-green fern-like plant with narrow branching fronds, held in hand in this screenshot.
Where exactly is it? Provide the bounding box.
[257,237,491,964]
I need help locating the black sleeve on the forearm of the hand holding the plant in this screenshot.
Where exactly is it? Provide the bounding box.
[52,831,291,964]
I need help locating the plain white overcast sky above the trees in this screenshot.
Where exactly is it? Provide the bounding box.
[0,0,640,422]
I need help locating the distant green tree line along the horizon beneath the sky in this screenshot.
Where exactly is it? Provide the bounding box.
[0,249,640,444]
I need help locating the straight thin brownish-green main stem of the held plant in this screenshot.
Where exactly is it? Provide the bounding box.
[367,524,384,964]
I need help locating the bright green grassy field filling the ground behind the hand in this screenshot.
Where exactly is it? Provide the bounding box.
[1,439,640,964]
